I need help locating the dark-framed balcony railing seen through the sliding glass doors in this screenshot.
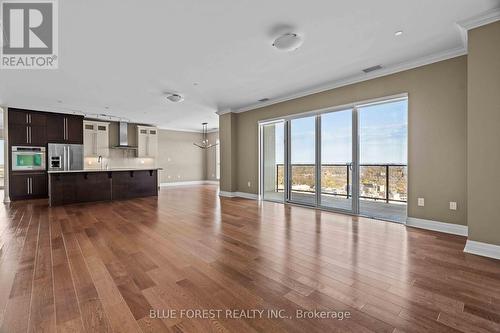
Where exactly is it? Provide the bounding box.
[275,164,408,203]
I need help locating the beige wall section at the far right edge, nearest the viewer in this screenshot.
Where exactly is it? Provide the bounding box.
[467,22,500,245]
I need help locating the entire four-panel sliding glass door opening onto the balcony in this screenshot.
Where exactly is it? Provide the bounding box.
[260,94,408,222]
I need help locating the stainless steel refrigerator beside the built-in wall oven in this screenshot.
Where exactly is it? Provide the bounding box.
[49,143,83,171]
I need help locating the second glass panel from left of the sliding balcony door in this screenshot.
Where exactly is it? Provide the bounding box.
[288,116,316,206]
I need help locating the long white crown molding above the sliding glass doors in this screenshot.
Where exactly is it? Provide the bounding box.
[225,45,467,115]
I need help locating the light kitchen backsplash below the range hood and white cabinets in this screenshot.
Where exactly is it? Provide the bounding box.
[84,149,156,169]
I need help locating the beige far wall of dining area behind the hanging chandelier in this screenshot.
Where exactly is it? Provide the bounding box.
[157,129,206,183]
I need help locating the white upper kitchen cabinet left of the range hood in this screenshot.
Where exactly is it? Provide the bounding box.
[83,120,109,157]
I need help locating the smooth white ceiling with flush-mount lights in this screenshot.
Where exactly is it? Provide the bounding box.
[0,0,500,130]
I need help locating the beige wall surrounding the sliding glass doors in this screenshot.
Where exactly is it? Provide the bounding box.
[219,56,467,225]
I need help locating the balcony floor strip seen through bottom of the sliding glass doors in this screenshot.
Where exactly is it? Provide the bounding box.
[264,192,407,223]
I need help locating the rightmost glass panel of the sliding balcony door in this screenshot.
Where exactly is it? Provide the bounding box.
[358,99,408,222]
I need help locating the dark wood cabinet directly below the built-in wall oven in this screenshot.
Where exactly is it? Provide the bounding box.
[9,172,48,200]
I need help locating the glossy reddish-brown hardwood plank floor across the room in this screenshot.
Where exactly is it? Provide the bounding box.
[0,185,500,333]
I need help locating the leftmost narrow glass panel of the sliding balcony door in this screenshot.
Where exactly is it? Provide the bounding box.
[260,121,285,202]
